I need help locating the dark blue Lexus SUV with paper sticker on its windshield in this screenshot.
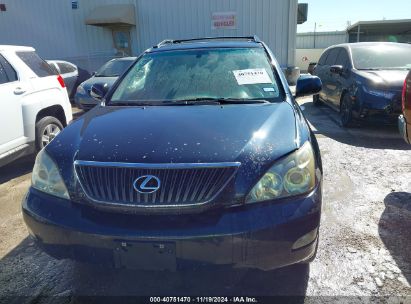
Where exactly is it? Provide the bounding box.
[23,37,322,270]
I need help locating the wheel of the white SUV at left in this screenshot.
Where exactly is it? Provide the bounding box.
[36,116,63,152]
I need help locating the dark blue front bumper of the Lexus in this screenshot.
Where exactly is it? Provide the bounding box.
[23,186,321,270]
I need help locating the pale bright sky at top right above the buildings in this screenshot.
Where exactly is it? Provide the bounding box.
[297,0,411,33]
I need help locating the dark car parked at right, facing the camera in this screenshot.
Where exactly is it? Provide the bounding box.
[313,42,411,127]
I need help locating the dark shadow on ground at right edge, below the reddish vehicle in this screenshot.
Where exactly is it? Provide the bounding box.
[378,192,411,284]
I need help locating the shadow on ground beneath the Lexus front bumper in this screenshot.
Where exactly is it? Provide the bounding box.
[0,238,309,303]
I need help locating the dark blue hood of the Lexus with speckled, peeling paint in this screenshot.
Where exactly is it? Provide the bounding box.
[46,102,309,200]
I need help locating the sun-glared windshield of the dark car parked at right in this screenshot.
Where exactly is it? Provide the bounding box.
[351,44,411,70]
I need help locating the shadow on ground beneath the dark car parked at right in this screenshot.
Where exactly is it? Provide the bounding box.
[301,101,411,150]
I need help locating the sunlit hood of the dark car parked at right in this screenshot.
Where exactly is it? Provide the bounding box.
[358,70,409,90]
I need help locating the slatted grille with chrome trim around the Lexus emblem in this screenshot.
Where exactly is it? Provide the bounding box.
[75,161,240,207]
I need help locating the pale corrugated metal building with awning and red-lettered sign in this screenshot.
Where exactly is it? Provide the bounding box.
[0,0,298,71]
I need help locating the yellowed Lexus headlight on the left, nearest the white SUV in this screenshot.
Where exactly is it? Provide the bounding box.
[31,149,70,199]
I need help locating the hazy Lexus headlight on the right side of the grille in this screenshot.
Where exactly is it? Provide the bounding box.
[246,141,315,203]
